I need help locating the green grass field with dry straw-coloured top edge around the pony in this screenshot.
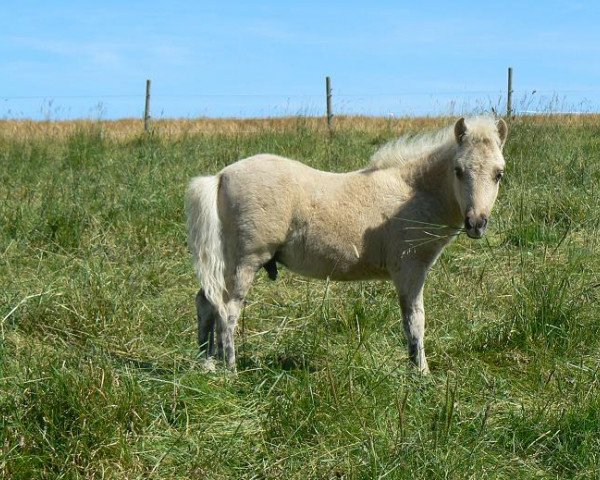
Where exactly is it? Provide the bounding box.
[0,117,600,479]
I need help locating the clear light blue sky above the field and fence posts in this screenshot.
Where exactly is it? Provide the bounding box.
[0,0,600,120]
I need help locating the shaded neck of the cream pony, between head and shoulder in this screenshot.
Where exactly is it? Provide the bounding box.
[409,144,463,229]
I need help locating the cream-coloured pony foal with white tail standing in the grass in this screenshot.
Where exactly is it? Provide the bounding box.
[186,117,508,373]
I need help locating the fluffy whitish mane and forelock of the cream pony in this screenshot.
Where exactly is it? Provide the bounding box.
[367,117,498,170]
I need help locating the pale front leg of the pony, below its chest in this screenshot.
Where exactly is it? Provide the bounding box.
[393,262,429,374]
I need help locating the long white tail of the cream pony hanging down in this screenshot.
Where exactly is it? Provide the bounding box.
[185,175,227,318]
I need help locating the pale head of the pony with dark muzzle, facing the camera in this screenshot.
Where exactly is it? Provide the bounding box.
[452,118,508,238]
